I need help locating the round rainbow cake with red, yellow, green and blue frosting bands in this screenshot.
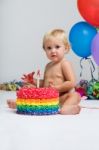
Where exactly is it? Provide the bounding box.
[16,87,59,115]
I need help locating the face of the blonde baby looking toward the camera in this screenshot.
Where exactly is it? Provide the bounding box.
[45,38,66,62]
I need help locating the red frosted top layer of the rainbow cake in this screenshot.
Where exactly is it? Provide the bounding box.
[17,87,59,99]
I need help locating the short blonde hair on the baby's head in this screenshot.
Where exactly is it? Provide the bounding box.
[43,29,70,51]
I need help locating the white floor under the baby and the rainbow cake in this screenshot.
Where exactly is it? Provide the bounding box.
[0,91,99,150]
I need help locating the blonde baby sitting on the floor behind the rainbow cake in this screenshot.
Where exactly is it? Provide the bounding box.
[8,29,81,115]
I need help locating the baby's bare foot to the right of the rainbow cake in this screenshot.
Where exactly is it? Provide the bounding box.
[60,105,81,115]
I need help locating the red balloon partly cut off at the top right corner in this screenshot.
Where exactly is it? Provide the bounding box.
[77,0,99,27]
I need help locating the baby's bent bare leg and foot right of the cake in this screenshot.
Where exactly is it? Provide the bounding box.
[60,92,81,115]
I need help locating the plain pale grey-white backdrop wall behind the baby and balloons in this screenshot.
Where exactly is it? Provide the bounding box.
[0,0,97,82]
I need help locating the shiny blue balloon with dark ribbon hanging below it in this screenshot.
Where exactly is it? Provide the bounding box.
[69,22,97,58]
